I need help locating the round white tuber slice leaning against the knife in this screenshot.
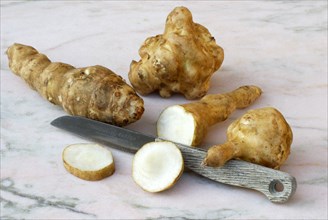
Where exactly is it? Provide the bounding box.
[132,141,183,192]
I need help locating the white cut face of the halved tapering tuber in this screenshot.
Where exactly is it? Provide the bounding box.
[157,105,196,145]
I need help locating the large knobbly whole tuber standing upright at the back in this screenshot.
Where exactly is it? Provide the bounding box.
[129,7,224,99]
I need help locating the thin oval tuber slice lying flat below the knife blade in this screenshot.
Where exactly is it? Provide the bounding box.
[62,143,115,181]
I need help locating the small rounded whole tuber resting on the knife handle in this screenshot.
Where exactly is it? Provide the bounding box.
[203,107,293,169]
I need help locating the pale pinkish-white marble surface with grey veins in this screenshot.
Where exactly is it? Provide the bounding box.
[0,1,328,219]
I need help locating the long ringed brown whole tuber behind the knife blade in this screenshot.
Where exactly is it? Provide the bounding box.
[7,43,144,126]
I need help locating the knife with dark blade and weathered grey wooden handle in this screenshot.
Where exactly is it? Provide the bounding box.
[51,116,297,203]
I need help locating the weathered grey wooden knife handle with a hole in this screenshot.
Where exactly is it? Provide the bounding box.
[170,141,297,203]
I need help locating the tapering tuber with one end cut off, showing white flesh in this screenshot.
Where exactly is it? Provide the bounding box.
[157,86,262,146]
